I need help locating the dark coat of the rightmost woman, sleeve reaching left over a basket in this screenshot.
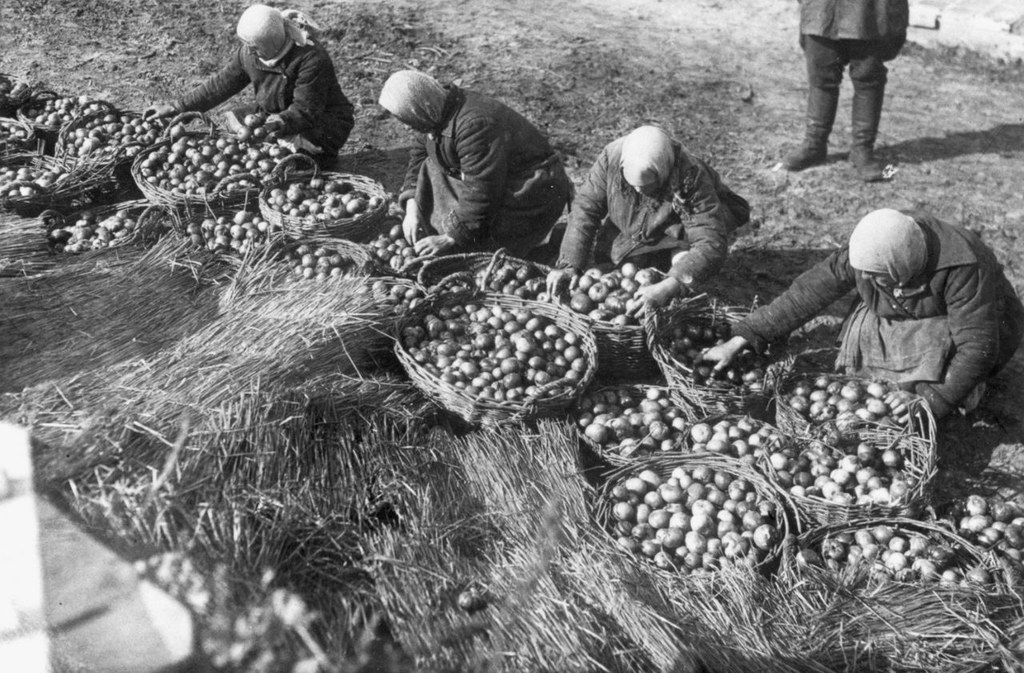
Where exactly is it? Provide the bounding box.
[733,212,1024,416]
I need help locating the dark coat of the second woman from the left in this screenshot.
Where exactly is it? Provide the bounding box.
[398,85,572,254]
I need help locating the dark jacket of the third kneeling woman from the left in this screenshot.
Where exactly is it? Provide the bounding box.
[557,138,749,284]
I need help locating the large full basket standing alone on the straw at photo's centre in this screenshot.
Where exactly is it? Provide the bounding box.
[395,292,597,425]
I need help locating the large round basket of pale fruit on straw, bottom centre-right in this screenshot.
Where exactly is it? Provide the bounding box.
[595,453,791,576]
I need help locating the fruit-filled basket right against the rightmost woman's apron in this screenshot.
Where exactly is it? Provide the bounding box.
[773,369,936,441]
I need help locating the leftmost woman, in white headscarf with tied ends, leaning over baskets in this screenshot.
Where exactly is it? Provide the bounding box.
[145,4,354,164]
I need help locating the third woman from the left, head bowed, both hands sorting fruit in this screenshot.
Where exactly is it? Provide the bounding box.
[548,126,750,306]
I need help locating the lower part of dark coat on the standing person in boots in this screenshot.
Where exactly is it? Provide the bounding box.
[800,0,910,40]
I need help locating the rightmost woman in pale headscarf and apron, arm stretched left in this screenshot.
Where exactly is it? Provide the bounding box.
[705,209,1024,418]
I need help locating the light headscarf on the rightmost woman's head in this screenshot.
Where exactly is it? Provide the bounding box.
[850,208,928,286]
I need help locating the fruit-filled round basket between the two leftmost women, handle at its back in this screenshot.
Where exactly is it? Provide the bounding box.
[259,155,388,243]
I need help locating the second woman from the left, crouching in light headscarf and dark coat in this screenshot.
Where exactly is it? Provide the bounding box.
[380,70,571,256]
